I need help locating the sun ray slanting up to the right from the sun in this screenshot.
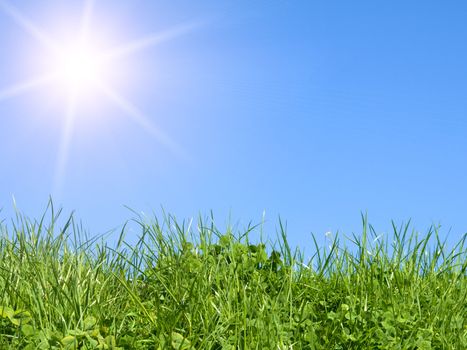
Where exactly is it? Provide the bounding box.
[102,21,201,61]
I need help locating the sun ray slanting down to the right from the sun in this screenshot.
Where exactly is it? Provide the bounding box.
[99,82,188,159]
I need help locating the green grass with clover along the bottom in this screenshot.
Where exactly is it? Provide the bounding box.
[0,207,467,349]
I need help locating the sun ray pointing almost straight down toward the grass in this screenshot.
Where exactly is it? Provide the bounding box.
[53,94,77,198]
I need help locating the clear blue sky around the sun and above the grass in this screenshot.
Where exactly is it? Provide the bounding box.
[0,0,467,249]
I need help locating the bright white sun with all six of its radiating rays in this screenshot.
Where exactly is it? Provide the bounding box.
[0,0,198,191]
